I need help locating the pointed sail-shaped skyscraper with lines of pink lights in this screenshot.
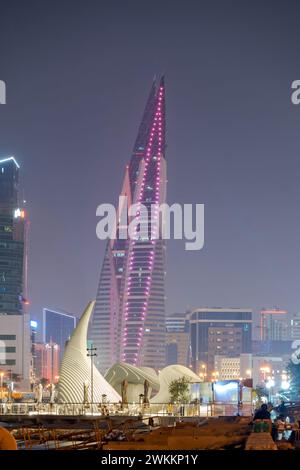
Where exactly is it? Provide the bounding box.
[89,78,166,372]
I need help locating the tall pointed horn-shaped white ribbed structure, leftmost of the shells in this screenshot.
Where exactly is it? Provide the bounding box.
[57,302,121,403]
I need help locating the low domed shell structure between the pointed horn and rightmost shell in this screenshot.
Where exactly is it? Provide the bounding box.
[105,363,159,403]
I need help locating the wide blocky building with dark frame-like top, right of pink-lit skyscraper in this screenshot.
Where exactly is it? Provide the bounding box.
[190,308,252,375]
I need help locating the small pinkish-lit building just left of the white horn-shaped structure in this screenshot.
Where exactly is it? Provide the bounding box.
[35,341,60,383]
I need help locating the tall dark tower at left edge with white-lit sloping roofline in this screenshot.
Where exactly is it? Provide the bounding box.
[0,157,30,386]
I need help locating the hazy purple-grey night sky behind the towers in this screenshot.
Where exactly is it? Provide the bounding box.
[0,0,300,336]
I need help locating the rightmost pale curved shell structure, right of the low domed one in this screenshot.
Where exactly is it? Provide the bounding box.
[150,364,200,403]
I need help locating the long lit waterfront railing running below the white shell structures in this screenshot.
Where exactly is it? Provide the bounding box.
[0,402,253,417]
